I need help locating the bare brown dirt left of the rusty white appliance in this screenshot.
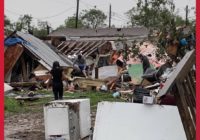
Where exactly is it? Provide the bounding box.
[4,112,45,140]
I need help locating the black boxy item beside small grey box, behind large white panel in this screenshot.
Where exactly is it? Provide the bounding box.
[133,87,150,103]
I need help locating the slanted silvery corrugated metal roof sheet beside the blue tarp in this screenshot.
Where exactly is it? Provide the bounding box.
[16,32,72,69]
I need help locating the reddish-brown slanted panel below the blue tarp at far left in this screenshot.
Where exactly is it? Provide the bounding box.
[4,45,24,79]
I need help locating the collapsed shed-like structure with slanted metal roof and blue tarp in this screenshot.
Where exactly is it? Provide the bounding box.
[4,31,72,82]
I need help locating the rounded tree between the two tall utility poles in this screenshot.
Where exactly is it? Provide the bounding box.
[81,7,107,29]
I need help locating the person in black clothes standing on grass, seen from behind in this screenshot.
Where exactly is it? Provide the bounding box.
[50,61,66,100]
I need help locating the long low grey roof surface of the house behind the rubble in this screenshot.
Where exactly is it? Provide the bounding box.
[49,27,149,37]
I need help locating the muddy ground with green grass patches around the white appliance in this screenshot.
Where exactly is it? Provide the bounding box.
[4,91,120,140]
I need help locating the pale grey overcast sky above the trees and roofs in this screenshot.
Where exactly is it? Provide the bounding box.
[4,0,196,29]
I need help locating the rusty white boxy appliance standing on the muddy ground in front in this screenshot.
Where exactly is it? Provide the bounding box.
[44,99,91,140]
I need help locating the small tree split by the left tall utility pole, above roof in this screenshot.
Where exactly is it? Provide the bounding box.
[65,16,84,28]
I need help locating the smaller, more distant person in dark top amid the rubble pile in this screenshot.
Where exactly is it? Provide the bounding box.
[73,54,88,78]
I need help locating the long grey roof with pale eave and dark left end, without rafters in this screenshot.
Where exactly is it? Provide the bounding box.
[48,27,149,46]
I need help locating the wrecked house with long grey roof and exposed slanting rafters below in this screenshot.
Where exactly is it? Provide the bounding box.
[48,27,149,67]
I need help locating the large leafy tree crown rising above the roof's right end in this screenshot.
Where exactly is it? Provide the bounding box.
[126,0,175,28]
